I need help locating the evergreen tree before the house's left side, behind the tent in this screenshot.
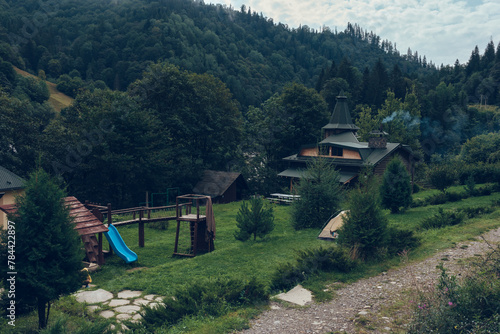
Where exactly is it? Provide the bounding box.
[292,158,342,230]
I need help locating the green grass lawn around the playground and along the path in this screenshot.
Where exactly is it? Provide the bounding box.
[4,187,500,333]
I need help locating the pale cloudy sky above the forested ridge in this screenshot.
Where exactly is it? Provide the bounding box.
[214,0,500,66]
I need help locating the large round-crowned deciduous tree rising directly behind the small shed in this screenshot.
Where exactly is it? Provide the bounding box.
[129,63,243,169]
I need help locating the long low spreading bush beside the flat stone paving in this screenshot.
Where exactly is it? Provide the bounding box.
[131,278,269,333]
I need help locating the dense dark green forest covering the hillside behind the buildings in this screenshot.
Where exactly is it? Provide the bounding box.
[0,0,500,206]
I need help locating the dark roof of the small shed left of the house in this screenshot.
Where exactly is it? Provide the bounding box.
[193,170,247,197]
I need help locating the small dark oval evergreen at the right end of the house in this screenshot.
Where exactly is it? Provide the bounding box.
[380,158,412,213]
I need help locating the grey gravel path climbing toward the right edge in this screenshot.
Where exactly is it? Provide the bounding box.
[241,229,500,334]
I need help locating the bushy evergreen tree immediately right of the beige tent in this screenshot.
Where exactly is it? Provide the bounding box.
[338,176,387,259]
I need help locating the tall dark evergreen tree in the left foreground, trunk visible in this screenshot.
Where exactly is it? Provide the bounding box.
[4,170,83,328]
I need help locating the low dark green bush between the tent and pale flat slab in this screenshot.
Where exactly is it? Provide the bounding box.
[271,246,355,291]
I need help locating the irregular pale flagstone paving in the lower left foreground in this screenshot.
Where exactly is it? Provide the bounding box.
[75,285,163,329]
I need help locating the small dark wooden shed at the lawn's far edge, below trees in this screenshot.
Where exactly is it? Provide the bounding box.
[193,170,248,203]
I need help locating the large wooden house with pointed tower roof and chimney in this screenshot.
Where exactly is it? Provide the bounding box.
[278,95,415,189]
